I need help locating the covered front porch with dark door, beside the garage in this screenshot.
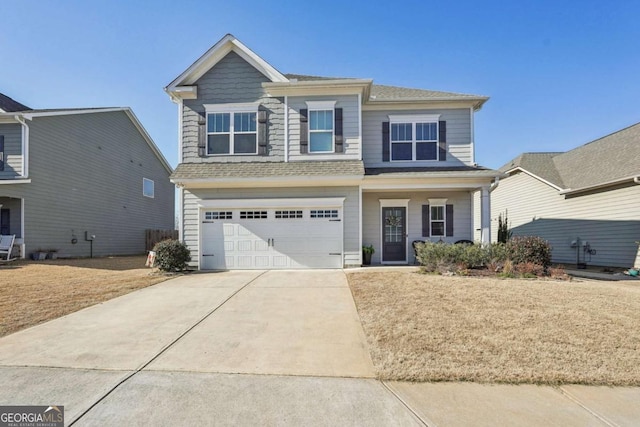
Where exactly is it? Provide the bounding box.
[362,168,499,265]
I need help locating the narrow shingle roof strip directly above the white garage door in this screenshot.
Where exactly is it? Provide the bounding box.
[171,160,364,180]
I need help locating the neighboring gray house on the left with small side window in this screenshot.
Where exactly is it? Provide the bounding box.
[0,94,175,257]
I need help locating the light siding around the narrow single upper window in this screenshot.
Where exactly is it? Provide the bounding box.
[287,95,361,161]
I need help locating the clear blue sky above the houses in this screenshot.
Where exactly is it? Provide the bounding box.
[0,0,640,168]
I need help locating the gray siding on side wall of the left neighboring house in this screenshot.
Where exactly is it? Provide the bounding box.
[0,112,175,257]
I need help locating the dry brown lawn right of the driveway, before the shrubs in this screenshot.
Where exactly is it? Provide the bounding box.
[348,272,640,386]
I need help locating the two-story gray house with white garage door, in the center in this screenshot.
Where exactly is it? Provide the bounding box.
[165,34,499,269]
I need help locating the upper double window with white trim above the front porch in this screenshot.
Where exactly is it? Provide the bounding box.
[389,115,439,161]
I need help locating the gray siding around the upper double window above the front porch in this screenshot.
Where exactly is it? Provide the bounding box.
[362,108,473,167]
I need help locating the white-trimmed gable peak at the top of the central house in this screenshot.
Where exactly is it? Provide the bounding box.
[165,33,288,96]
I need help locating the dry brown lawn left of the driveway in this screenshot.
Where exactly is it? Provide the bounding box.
[0,256,167,336]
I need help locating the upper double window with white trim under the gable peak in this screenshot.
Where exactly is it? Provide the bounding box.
[205,104,258,155]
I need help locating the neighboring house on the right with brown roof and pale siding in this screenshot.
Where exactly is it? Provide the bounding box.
[491,124,640,267]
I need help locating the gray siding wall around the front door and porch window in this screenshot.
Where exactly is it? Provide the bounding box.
[362,191,473,264]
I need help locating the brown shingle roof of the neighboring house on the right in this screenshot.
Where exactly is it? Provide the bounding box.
[500,123,640,189]
